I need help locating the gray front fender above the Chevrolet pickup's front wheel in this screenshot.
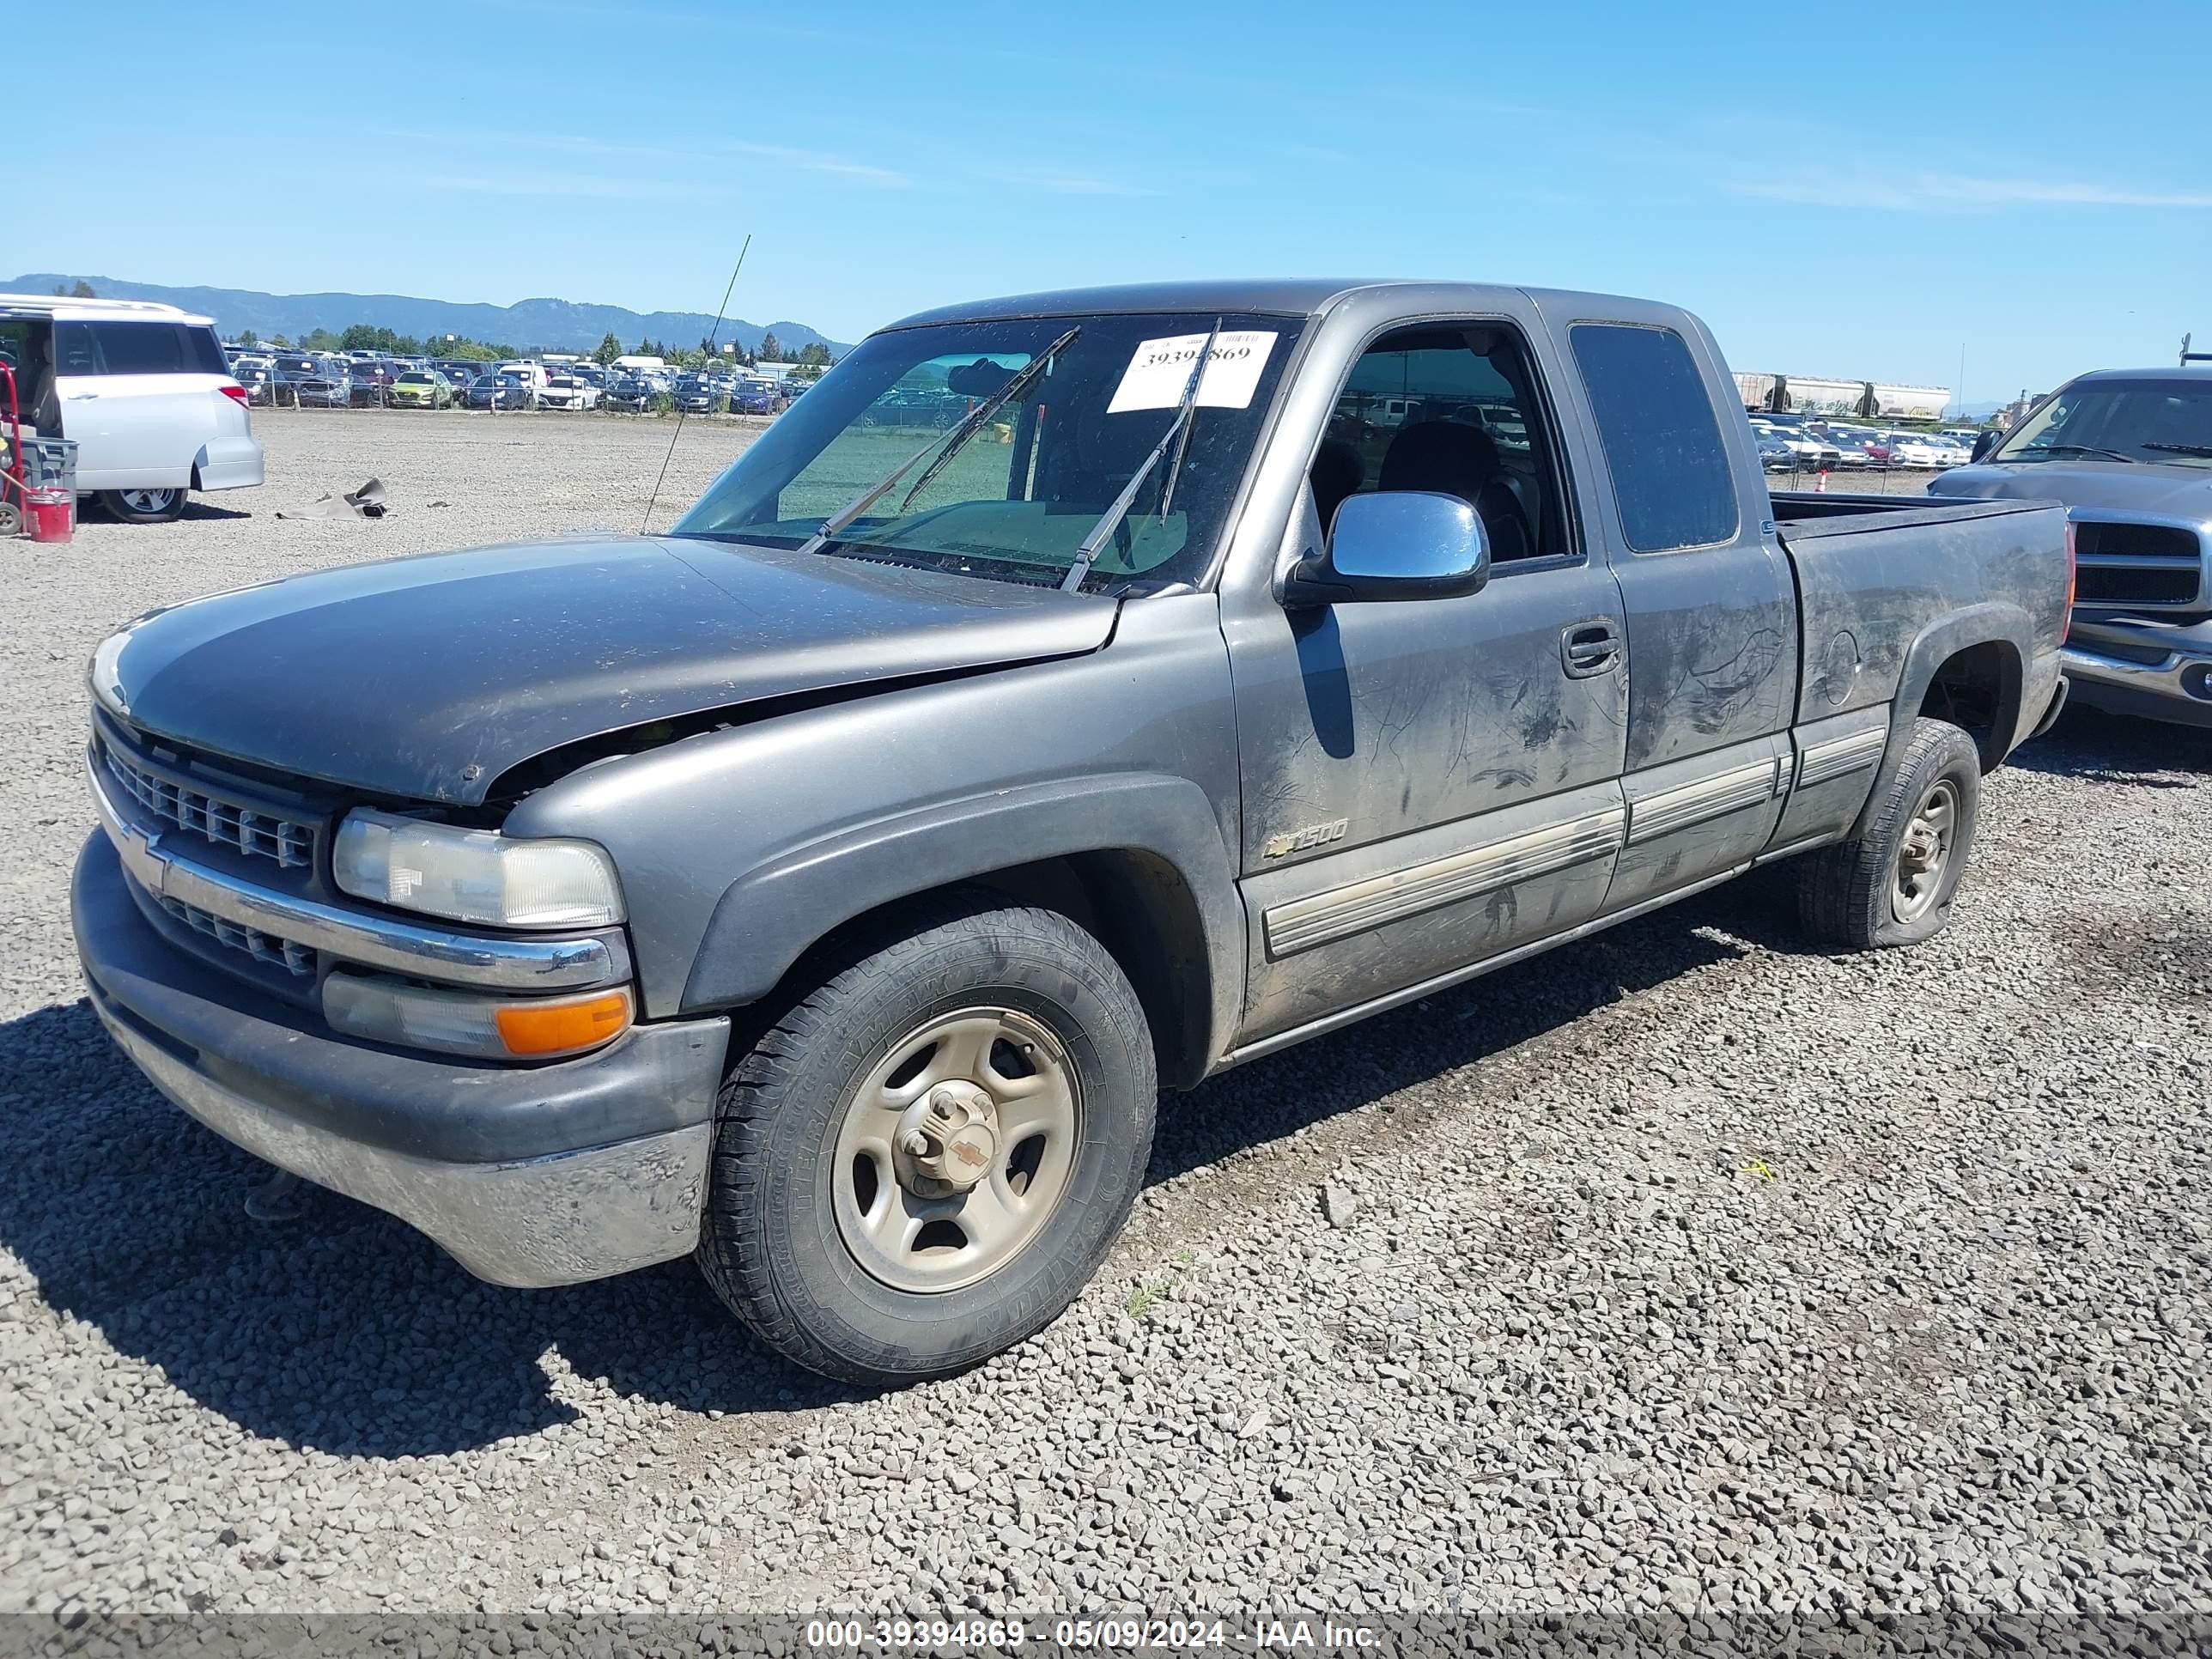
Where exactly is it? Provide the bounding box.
[504,592,1245,1053]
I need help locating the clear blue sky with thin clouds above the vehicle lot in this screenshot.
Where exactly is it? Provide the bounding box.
[21,0,2212,400]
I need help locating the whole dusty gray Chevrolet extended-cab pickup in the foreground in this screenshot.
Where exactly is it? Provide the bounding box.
[73,281,2069,1385]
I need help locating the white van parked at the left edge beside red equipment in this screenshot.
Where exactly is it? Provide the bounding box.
[0,295,261,525]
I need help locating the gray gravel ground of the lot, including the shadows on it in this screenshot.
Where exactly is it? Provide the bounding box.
[0,411,2212,1614]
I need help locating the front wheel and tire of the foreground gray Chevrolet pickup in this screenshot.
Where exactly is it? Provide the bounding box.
[696,894,1157,1387]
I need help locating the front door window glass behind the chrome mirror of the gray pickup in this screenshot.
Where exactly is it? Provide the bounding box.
[1312,323,1575,564]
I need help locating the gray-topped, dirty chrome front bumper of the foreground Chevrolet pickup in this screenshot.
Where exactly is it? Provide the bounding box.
[70,832,730,1285]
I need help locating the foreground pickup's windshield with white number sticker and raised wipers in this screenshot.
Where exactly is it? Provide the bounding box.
[672,312,1303,588]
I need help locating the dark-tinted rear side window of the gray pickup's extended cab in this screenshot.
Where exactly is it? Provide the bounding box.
[1566,323,1741,553]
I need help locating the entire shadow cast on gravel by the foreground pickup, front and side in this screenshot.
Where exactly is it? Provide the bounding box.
[0,883,1760,1458]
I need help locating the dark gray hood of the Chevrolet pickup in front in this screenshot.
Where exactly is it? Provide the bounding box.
[95,535,1119,805]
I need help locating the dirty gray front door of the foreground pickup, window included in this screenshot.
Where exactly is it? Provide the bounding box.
[1224,296,1628,1046]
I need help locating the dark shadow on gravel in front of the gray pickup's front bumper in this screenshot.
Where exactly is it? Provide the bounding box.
[0,1002,856,1458]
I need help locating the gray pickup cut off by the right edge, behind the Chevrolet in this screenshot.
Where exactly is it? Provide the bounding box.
[1929,358,2212,728]
